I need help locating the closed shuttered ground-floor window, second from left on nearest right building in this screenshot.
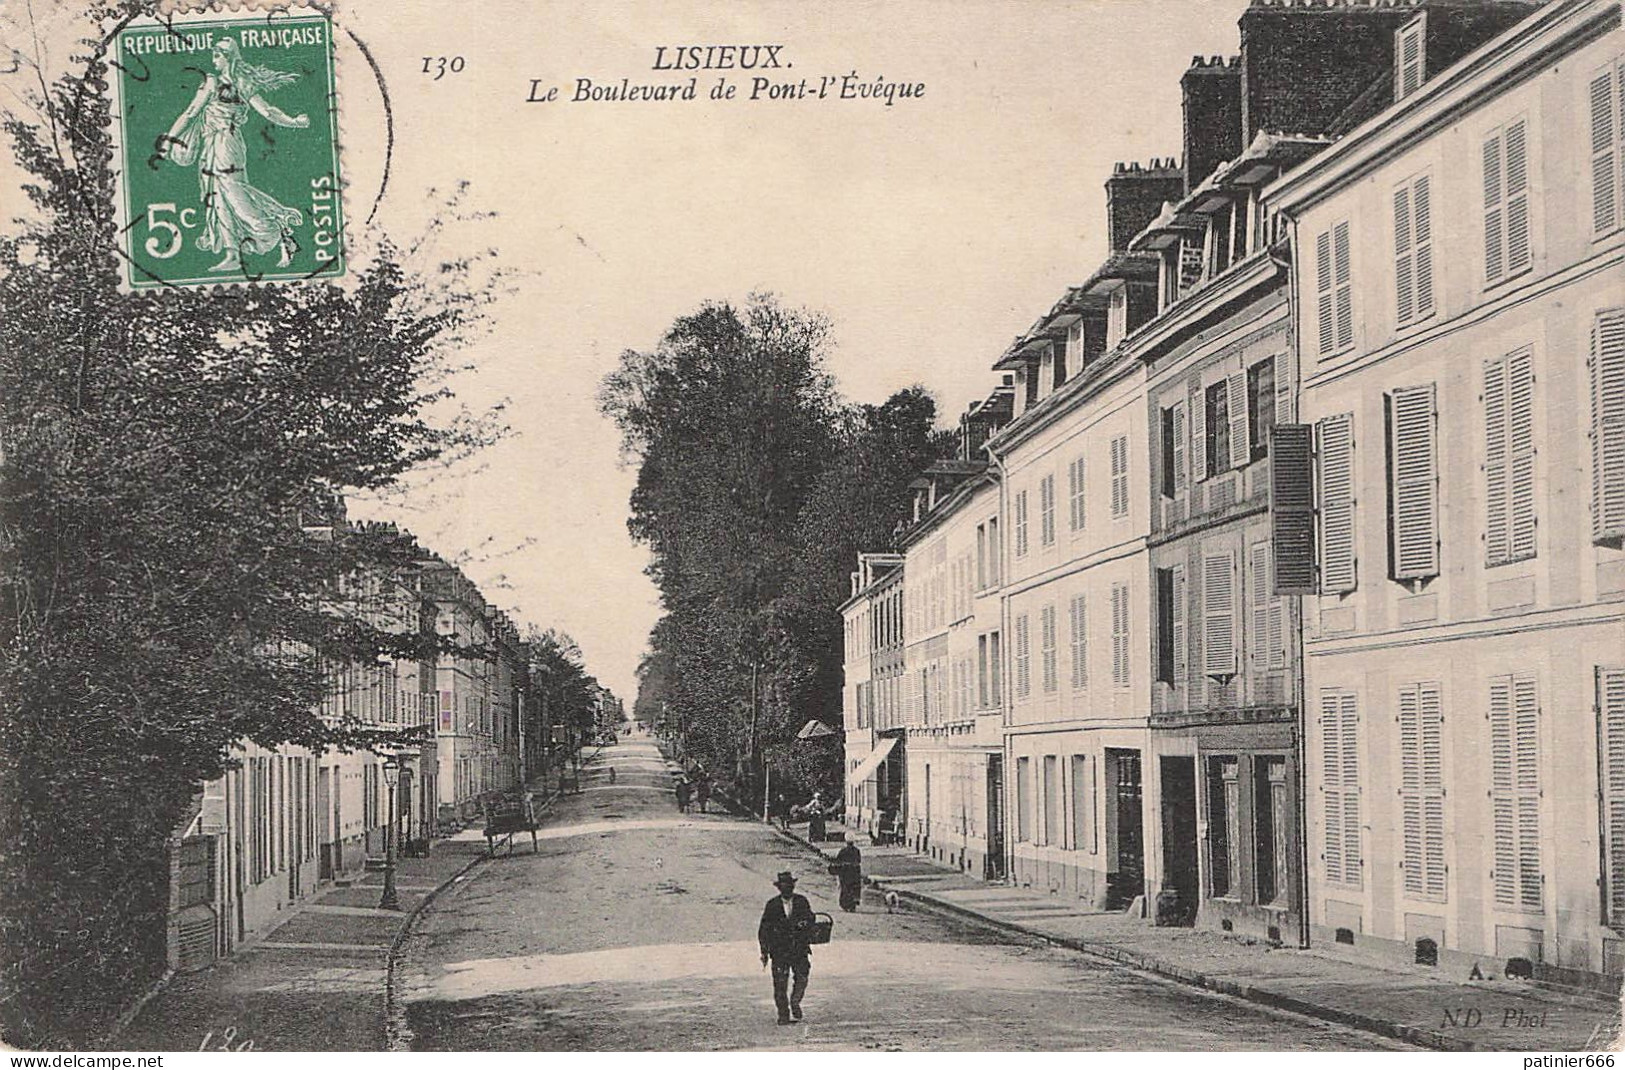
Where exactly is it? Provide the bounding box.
[1399,680,1445,901]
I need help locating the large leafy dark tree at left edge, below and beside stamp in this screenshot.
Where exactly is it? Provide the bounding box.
[0,5,507,1047]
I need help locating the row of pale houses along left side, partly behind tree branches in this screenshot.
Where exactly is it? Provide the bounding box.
[169,517,614,969]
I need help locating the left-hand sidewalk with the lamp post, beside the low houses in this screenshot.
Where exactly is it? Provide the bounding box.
[107,780,572,1052]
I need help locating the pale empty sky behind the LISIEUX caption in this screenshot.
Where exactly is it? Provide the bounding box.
[0,0,1245,701]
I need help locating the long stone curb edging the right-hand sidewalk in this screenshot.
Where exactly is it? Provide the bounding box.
[774,828,1475,1052]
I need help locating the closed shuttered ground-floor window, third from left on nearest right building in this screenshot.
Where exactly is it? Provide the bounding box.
[1490,673,1542,911]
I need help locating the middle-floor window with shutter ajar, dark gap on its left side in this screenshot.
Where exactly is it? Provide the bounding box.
[1388,382,1438,581]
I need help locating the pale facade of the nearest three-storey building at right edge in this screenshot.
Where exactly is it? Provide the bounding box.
[1266,0,1625,979]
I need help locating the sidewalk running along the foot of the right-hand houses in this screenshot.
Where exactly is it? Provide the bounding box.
[790,823,1620,1052]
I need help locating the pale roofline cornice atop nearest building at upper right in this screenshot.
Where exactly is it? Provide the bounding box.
[1264,0,1620,215]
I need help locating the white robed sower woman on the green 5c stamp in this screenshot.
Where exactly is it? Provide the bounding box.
[161,37,310,272]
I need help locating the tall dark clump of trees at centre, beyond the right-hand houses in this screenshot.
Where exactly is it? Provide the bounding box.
[600,294,952,798]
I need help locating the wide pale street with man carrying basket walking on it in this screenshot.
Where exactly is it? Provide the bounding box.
[400,740,1388,1050]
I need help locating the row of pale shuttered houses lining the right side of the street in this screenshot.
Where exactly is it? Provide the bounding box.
[843,0,1625,981]
